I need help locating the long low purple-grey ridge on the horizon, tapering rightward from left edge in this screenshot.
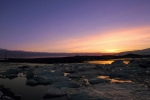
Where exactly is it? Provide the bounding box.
[0,48,112,58]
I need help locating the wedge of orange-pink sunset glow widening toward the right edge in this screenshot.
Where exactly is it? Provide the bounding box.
[14,26,150,53]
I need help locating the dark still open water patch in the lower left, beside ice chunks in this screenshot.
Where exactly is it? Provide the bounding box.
[0,77,67,100]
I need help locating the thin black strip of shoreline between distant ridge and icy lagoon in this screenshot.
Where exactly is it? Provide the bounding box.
[0,55,150,64]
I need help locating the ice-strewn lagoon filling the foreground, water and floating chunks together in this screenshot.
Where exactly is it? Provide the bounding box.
[0,60,150,100]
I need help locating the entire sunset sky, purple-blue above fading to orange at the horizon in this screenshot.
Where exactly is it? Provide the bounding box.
[0,0,150,53]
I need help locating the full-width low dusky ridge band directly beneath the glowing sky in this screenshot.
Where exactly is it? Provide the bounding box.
[0,48,150,58]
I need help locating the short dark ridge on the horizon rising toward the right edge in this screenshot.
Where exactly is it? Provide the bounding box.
[118,48,150,55]
